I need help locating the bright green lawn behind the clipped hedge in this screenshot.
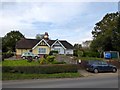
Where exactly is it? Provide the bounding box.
[2,60,40,66]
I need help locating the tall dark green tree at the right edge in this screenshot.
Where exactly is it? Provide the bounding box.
[91,12,120,52]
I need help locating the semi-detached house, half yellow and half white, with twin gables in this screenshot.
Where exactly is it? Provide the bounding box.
[16,34,73,58]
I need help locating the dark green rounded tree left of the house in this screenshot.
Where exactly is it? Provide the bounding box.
[2,31,24,52]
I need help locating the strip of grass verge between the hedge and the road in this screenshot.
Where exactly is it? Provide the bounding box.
[2,73,83,80]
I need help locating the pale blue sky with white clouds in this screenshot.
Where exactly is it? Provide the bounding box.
[0,2,118,45]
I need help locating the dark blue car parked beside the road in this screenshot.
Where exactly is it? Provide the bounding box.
[86,60,117,73]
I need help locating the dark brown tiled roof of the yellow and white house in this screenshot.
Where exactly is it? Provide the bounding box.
[16,38,73,49]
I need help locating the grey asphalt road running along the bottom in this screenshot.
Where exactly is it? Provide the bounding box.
[2,74,118,88]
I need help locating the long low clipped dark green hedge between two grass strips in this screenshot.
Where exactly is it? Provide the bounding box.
[2,64,77,74]
